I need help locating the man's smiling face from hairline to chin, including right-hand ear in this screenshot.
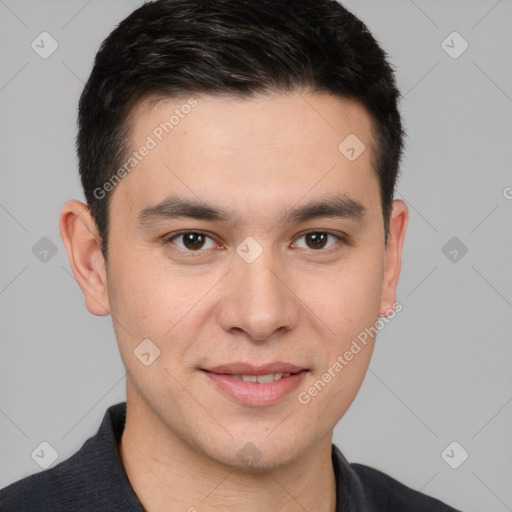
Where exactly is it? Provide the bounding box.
[64,94,407,468]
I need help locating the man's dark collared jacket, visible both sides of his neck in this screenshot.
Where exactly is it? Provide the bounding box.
[0,402,459,512]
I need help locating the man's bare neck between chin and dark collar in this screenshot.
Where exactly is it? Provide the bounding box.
[119,400,336,512]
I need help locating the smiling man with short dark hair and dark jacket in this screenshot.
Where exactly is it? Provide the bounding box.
[0,0,462,512]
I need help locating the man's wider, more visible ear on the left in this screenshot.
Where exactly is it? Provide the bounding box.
[59,200,110,316]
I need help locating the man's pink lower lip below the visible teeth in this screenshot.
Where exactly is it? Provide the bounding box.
[202,370,307,406]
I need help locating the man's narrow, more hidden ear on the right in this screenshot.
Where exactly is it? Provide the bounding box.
[379,199,409,317]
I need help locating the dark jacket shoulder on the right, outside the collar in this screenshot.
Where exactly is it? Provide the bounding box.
[350,463,460,512]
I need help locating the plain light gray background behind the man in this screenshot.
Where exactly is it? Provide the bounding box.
[0,0,512,512]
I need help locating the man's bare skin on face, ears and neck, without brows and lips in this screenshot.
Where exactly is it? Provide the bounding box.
[60,93,408,512]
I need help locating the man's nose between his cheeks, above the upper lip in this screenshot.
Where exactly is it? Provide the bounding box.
[218,250,300,341]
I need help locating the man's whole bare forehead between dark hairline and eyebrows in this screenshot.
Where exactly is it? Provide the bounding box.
[113,93,378,222]
